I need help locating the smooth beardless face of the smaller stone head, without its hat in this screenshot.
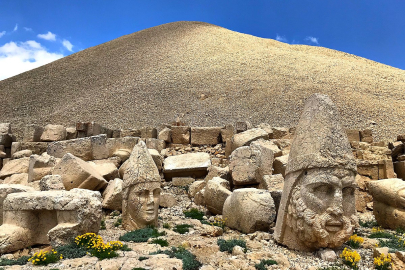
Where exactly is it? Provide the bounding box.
[123,182,160,229]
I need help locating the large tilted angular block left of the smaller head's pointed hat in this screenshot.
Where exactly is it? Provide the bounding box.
[53,153,107,190]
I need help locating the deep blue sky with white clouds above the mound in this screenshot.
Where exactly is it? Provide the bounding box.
[0,0,405,80]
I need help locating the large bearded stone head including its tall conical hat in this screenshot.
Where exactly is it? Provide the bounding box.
[274,94,357,251]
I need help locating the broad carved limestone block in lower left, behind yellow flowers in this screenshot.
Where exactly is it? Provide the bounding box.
[0,189,102,253]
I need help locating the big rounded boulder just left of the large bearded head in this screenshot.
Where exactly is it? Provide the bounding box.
[223,188,276,233]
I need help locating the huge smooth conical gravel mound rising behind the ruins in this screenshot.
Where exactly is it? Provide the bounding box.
[0,22,405,140]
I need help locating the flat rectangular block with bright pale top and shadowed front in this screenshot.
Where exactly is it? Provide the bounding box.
[163,153,211,179]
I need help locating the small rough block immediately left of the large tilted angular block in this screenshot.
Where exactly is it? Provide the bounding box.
[28,153,56,182]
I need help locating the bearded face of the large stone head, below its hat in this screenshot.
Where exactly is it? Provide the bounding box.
[286,168,358,249]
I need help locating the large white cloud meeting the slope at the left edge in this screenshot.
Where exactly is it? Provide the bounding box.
[0,40,63,80]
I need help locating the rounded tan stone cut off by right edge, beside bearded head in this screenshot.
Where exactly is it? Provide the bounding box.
[367,178,405,230]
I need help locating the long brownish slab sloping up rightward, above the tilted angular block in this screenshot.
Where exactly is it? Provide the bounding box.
[47,134,109,161]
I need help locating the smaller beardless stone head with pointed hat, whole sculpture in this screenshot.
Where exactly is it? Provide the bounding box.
[122,141,160,230]
